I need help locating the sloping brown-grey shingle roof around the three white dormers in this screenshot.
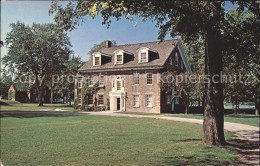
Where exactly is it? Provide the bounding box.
[79,39,178,71]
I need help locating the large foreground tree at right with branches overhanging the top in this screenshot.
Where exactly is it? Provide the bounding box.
[50,0,260,145]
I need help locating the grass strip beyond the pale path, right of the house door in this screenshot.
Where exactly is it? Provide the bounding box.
[121,112,259,127]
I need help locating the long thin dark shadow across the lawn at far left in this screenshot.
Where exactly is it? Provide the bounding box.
[1,111,80,118]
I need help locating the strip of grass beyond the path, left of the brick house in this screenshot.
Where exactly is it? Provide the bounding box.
[1,100,74,111]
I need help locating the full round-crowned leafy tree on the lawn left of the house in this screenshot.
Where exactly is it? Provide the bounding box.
[3,22,72,106]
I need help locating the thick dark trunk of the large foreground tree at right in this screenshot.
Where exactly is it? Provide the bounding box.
[202,2,225,145]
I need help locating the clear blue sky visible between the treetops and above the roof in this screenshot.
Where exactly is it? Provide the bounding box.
[1,1,171,61]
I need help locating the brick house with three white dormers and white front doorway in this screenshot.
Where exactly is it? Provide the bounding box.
[75,39,190,113]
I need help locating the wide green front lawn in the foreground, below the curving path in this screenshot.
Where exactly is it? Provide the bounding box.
[1,114,237,166]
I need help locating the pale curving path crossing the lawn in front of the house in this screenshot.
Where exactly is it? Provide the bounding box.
[1,110,259,166]
